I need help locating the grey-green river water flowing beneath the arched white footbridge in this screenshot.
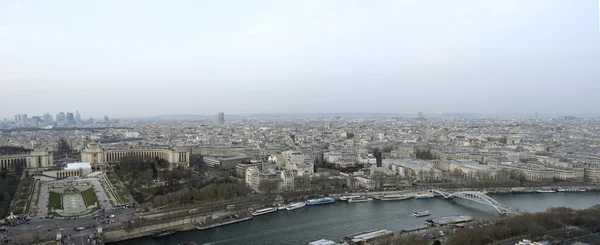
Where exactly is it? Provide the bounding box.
[116,192,600,245]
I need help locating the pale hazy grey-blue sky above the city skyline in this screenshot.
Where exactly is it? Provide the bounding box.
[0,0,600,119]
